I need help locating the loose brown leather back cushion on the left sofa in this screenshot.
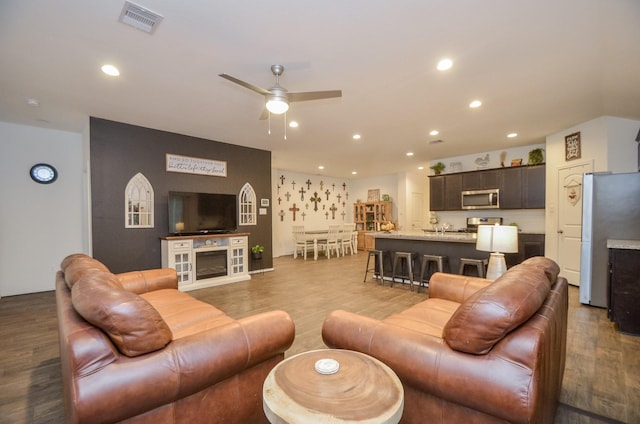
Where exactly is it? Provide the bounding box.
[71,272,172,357]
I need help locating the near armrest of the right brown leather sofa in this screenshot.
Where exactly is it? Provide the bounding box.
[322,308,536,420]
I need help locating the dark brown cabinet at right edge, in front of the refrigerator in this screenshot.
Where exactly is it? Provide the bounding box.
[607,249,640,335]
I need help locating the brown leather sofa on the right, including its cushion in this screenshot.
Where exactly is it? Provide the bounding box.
[322,257,568,424]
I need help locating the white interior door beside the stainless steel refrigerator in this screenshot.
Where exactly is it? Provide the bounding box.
[557,163,593,286]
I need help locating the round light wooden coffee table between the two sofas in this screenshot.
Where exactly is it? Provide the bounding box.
[263,349,404,424]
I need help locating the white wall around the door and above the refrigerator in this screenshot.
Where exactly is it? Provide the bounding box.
[545,116,640,260]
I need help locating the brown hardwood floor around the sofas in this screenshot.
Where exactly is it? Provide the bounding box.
[0,252,640,424]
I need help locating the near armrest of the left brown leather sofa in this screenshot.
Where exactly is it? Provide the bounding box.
[76,311,295,422]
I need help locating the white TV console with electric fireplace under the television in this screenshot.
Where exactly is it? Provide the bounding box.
[161,233,251,291]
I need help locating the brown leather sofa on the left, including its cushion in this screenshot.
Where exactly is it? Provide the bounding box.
[56,254,295,424]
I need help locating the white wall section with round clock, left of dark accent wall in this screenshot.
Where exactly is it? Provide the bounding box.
[0,122,89,297]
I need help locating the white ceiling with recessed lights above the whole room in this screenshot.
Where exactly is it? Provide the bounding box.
[0,0,640,178]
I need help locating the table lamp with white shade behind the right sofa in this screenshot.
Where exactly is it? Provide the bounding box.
[476,224,518,280]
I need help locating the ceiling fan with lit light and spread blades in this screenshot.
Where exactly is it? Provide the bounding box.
[219,65,342,119]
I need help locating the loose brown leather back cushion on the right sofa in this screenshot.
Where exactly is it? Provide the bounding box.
[443,264,551,355]
